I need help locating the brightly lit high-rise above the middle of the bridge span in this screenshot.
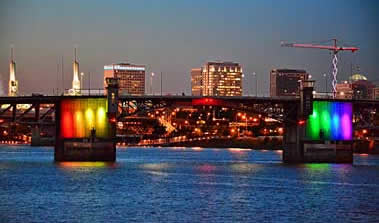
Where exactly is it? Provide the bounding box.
[191,62,243,96]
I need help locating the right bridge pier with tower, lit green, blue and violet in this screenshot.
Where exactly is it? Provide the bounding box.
[283,81,353,163]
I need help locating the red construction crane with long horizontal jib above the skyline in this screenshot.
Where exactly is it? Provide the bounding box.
[281,39,359,98]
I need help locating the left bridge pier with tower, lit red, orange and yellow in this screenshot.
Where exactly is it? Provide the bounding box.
[54,79,118,162]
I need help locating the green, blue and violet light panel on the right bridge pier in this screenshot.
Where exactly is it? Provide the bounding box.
[306,101,353,140]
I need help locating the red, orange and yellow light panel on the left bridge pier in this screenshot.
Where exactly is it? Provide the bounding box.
[61,98,111,138]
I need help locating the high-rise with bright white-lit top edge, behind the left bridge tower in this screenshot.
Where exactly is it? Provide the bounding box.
[104,63,145,95]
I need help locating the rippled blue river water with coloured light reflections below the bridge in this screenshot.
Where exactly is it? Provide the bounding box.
[0,146,379,223]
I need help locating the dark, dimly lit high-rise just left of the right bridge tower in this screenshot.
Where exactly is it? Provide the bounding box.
[270,69,309,96]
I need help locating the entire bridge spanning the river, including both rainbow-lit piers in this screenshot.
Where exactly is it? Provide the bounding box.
[0,78,379,163]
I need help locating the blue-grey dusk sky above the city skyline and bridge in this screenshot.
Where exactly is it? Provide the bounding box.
[0,0,379,94]
